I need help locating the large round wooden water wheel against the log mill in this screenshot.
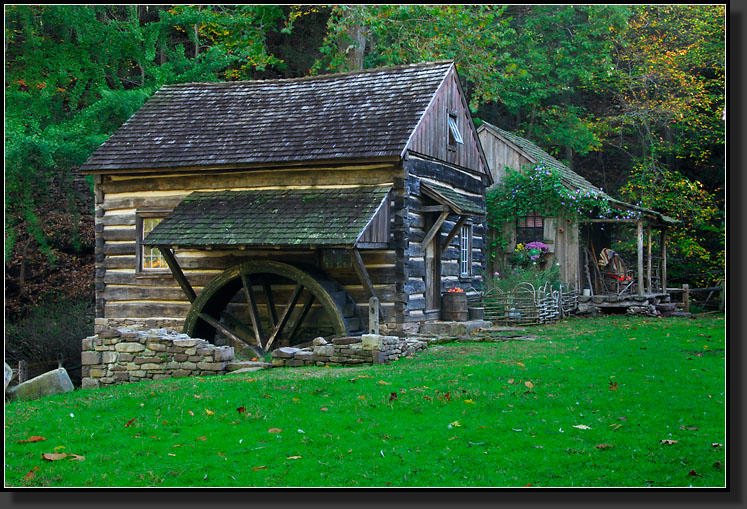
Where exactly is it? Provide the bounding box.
[184,261,361,352]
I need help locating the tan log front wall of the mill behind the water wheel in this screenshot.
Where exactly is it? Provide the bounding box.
[95,163,405,330]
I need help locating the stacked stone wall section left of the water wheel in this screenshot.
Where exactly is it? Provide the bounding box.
[81,328,234,388]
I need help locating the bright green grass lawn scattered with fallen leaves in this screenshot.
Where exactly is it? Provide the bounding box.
[5,316,727,487]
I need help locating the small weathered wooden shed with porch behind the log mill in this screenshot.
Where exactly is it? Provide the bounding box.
[477,122,676,301]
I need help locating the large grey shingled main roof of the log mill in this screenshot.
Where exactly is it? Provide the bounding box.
[81,62,453,174]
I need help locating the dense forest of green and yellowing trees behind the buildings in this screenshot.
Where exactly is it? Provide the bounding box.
[5,4,726,374]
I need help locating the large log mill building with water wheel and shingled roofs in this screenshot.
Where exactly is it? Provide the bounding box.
[81,62,492,350]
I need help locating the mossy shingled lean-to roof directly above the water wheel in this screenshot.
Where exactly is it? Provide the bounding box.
[144,186,390,248]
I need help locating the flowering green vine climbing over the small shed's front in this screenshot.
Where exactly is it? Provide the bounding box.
[487,164,612,258]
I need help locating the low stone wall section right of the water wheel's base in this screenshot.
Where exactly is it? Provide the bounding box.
[272,334,427,367]
